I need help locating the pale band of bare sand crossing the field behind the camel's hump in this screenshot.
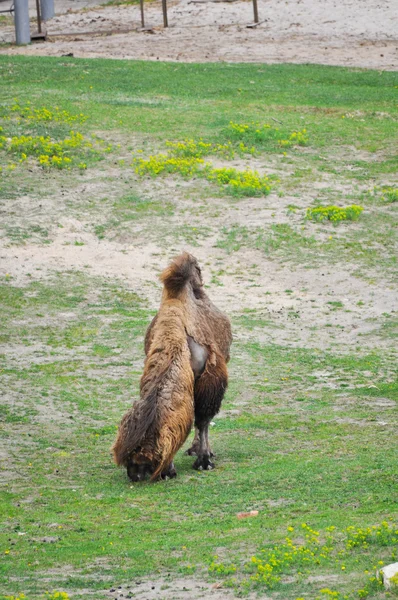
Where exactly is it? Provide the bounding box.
[0,188,398,349]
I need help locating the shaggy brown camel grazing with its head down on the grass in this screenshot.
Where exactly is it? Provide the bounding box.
[113,253,232,481]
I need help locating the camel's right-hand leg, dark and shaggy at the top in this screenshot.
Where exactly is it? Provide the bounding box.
[188,355,228,470]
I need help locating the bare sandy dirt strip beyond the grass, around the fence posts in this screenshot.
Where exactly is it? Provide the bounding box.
[0,0,398,70]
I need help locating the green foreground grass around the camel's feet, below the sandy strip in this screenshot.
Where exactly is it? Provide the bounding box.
[2,275,396,599]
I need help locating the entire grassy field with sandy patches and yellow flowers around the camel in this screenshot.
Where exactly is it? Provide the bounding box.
[0,56,398,600]
